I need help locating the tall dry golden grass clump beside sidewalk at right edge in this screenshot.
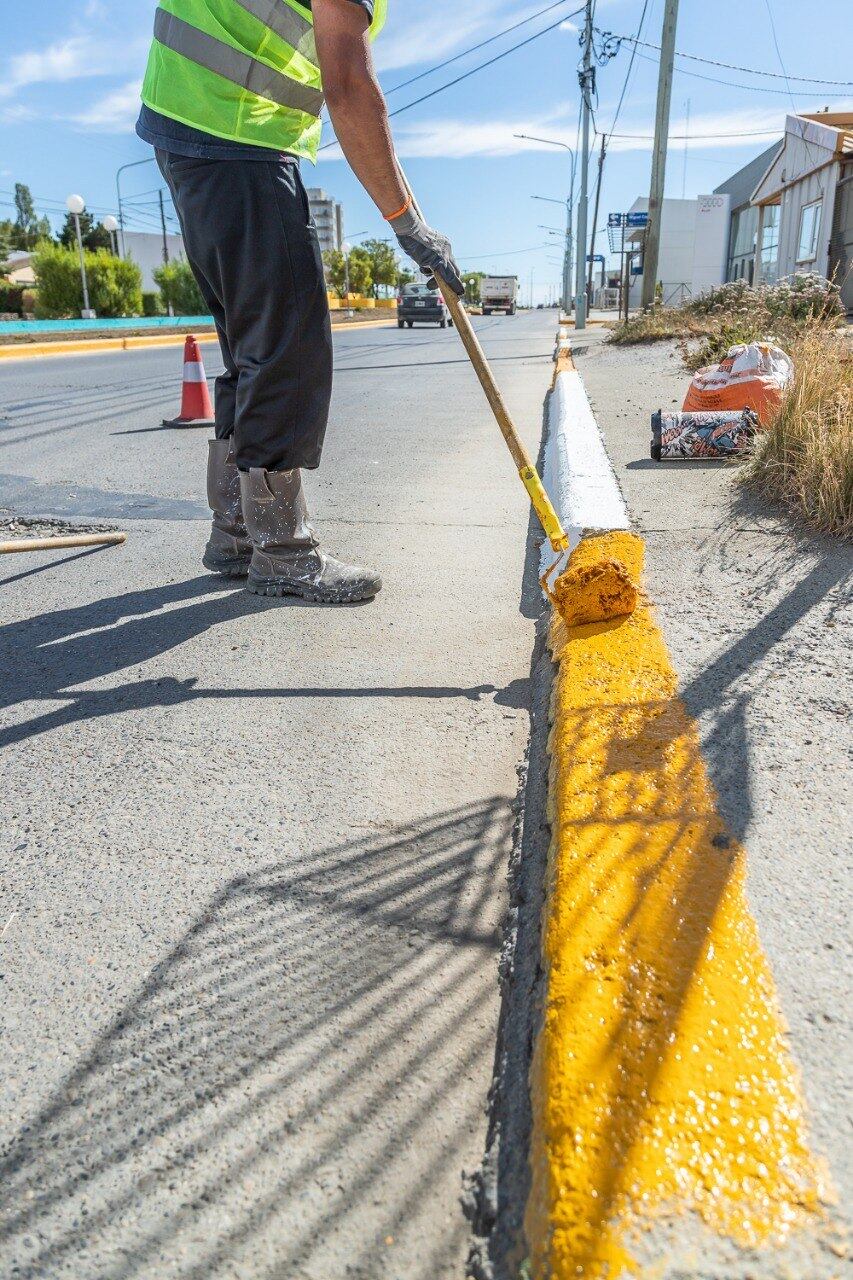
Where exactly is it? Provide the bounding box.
[743,328,853,538]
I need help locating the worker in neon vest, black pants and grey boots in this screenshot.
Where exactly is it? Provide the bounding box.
[136,0,464,604]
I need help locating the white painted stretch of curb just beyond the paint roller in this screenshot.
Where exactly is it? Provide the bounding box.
[542,355,630,572]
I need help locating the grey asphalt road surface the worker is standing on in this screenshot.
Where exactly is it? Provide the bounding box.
[0,312,555,1280]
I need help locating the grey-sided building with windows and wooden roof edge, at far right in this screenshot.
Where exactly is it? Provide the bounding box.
[752,111,853,312]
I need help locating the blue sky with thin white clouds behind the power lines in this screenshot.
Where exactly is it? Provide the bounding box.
[0,0,853,301]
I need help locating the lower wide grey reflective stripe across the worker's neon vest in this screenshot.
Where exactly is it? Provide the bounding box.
[154,0,323,115]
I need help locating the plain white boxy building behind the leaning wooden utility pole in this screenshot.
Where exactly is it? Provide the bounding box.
[625,193,731,307]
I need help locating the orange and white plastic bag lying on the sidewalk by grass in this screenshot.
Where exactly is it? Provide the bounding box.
[681,342,794,426]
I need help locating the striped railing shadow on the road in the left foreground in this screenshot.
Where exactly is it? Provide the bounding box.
[0,797,512,1280]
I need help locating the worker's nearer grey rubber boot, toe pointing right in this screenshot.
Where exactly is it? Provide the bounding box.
[240,467,382,604]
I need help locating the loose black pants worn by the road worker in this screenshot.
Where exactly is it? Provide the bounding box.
[158,151,332,471]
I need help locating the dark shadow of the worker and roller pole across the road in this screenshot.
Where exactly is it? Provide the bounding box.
[0,573,528,748]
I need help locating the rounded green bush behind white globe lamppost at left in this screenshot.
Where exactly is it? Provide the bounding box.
[33,243,142,319]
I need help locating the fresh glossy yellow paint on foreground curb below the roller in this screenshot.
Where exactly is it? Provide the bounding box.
[526,534,829,1280]
